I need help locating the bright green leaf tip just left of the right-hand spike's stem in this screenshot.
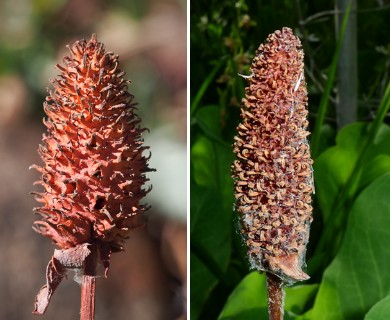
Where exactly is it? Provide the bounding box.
[218,271,268,320]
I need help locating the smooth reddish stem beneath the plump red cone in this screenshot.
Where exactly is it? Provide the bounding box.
[80,245,97,320]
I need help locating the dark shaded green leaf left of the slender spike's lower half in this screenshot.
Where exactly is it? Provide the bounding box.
[190,184,232,319]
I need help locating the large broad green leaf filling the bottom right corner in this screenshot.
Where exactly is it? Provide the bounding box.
[305,173,390,320]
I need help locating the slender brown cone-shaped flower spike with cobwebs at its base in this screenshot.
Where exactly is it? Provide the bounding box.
[232,28,314,282]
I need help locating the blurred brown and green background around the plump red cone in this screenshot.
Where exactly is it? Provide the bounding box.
[0,0,187,320]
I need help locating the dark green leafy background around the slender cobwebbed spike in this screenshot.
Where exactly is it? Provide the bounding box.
[190,0,390,320]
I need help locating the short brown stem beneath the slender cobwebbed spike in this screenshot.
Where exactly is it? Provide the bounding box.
[266,272,284,320]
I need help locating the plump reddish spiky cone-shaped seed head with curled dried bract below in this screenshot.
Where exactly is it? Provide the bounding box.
[32,35,152,314]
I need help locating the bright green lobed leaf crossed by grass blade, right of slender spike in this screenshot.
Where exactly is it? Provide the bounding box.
[314,123,390,221]
